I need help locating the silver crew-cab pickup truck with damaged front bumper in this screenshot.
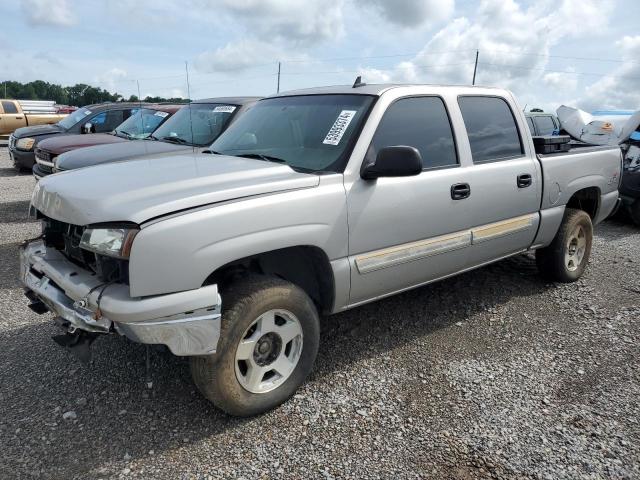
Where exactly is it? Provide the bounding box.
[21,84,621,415]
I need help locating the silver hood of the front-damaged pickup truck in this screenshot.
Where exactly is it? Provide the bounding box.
[31,152,319,225]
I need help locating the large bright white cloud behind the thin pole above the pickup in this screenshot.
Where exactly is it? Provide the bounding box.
[358,0,610,98]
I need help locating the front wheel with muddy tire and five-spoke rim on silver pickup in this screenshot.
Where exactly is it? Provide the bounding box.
[191,276,320,417]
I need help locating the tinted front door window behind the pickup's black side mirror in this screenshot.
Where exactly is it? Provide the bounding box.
[368,97,458,168]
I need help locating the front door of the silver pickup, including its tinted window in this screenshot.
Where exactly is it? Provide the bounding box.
[347,96,472,305]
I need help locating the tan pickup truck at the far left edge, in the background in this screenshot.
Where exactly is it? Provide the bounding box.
[0,99,66,135]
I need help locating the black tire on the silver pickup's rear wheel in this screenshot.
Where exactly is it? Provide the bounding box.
[536,208,593,283]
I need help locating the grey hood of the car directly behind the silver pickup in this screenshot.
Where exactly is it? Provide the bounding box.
[56,139,193,170]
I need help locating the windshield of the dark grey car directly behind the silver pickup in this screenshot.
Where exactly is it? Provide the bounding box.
[153,103,239,147]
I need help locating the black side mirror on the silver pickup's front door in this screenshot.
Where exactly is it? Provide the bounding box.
[360,145,422,180]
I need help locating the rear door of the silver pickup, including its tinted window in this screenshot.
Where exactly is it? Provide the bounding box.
[458,95,542,266]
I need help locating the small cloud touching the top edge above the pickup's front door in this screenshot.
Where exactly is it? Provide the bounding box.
[364,0,455,27]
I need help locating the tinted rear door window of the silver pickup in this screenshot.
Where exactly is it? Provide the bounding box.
[458,96,524,163]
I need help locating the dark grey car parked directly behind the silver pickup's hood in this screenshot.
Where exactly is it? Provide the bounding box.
[53,97,260,172]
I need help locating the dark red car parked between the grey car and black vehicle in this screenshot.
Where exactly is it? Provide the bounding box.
[33,104,182,179]
